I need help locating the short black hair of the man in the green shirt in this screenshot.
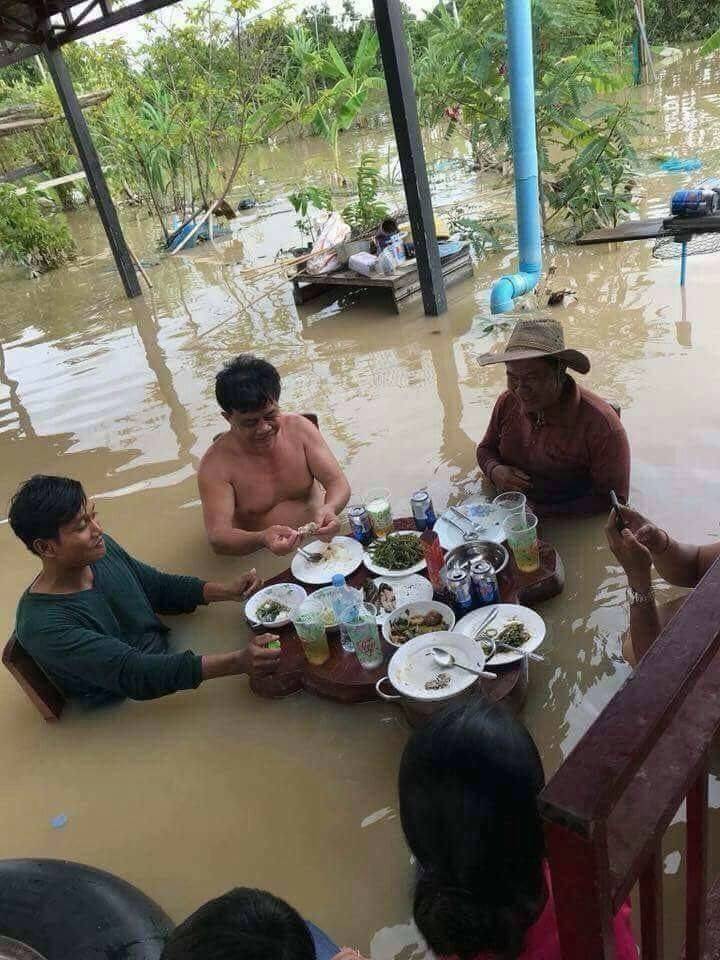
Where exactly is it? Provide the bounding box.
[8,474,87,553]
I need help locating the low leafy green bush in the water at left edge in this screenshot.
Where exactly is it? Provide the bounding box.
[0,184,75,270]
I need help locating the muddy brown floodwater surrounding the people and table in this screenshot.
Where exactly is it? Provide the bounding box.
[0,43,720,960]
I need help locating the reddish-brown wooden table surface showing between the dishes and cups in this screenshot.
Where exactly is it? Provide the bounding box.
[250,518,565,722]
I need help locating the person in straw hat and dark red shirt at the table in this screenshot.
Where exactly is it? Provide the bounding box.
[477,320,630,516]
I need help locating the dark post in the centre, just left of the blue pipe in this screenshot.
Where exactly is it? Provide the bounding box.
[373,0,447,317]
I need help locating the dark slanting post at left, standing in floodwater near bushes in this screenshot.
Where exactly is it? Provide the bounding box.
[43,45,142,297]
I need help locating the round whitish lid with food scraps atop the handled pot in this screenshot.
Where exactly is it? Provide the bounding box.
[388,630,485,701]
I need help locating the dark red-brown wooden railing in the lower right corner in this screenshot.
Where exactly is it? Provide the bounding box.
[541,561,720,960]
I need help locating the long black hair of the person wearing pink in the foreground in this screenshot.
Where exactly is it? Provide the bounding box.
[399,700,545,960]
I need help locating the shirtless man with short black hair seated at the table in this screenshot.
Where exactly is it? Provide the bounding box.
[198,354,350,555]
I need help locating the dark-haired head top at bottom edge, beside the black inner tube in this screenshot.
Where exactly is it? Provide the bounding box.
[160,887,315,960]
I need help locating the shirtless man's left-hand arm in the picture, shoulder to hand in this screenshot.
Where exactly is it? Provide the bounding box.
[198,464,298,557]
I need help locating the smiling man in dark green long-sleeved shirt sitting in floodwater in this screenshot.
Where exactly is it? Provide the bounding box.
[9,476,280,704]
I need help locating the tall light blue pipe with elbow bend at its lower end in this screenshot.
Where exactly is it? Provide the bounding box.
[490,0,542,313]
